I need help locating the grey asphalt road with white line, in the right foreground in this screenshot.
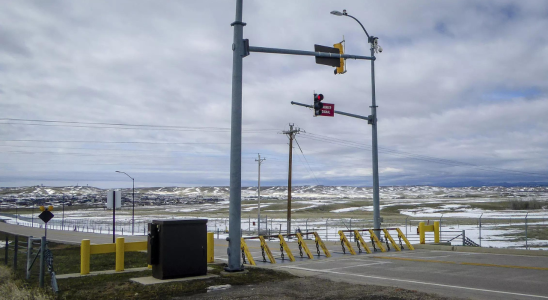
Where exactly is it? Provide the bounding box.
[215,240,548,299]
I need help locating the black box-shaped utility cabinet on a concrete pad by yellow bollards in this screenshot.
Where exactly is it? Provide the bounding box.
[148,219,207,279]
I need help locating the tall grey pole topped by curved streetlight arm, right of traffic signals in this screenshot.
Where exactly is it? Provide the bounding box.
[331,9,382,235]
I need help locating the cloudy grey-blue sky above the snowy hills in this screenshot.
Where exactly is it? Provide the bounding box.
[0,0,548,187]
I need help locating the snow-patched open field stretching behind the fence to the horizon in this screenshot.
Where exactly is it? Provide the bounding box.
[0,186,548,250]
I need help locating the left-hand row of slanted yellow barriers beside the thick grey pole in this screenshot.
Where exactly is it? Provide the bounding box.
[240,232,331,266]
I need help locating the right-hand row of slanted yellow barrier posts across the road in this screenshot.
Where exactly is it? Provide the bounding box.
[339,228,415,255]
